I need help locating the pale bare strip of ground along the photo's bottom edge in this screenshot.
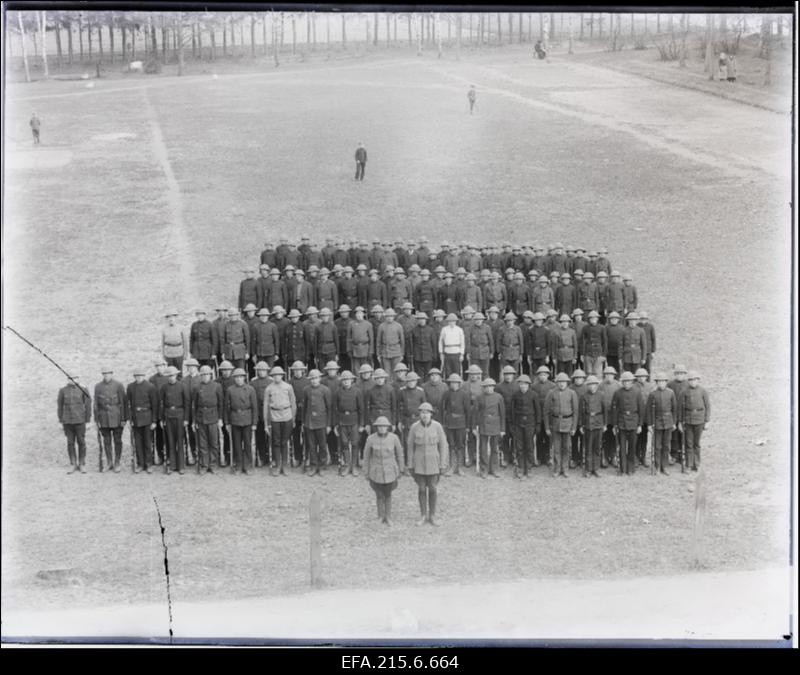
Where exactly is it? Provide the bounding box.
[3,569,792,640]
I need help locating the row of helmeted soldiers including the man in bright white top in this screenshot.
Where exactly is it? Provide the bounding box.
[161,303,656,386]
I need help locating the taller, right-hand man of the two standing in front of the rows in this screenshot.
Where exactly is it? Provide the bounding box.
[406,403,448,525]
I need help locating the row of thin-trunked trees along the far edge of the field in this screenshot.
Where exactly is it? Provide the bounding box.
[6,10,783,82]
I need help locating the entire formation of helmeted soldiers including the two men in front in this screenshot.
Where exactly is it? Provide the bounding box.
[58,237,710,522]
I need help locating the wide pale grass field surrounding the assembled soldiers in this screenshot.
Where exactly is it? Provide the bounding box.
[2,46,791,628]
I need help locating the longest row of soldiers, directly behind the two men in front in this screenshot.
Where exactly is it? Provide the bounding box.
[58,359,710,478]
